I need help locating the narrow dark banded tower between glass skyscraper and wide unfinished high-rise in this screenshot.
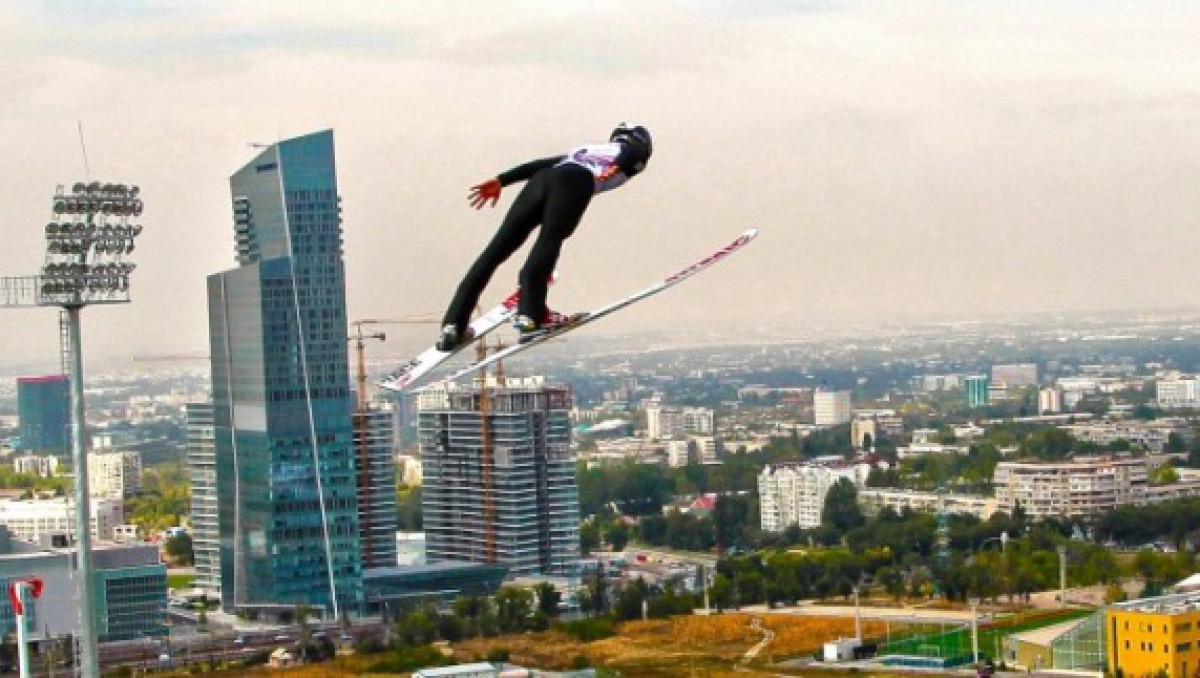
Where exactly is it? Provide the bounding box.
[354,408,400,569]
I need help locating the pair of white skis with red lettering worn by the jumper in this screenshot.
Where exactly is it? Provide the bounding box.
[379,228,758,391]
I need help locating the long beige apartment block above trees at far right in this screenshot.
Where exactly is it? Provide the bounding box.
[992,457,1146,520]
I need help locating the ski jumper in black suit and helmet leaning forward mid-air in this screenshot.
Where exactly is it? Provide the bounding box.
[444,142,649,332]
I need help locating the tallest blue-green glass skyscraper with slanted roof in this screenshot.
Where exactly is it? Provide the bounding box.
[208,131,362,613]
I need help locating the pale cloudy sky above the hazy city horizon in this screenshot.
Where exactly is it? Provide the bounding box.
[0,0,1200,366]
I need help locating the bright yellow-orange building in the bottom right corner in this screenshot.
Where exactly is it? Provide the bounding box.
[1105,593,1200,678]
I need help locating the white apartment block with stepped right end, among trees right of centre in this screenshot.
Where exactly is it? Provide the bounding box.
[758,462,871,532]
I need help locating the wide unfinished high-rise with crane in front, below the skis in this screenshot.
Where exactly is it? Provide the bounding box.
[419,378,580,576]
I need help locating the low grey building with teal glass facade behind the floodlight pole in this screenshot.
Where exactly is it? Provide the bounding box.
[0,528,168,642]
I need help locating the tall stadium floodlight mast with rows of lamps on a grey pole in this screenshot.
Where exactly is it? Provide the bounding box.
[36,181,142,678]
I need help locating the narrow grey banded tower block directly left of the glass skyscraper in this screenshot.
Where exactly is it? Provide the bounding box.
[184,402,221,595]
